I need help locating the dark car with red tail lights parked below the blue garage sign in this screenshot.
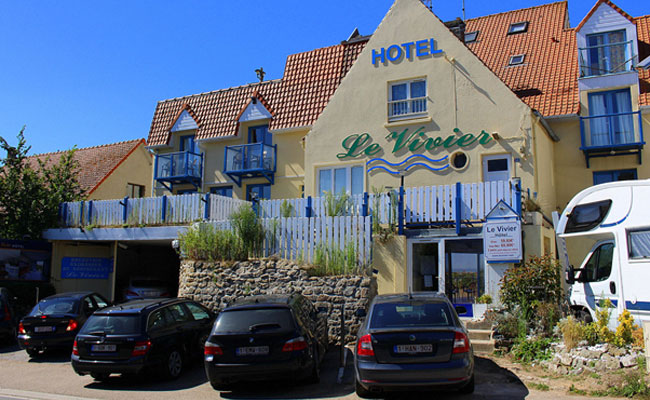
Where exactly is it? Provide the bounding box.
[18,292,110,357]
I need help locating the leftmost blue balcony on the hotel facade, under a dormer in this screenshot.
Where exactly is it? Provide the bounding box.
[154,151,203,191]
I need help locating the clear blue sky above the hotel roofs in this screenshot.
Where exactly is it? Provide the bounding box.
[0,0,650,156]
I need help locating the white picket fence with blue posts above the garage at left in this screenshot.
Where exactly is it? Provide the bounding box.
[62,193,250,227]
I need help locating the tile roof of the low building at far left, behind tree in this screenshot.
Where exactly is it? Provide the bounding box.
[27,139,146,195]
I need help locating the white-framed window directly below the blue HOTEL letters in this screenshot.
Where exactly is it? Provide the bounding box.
[388,79,427,120]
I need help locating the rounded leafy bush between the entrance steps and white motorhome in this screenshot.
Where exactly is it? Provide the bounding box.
[501,255,564,321]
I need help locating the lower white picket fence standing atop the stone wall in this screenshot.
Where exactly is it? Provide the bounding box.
[211,216,372,265]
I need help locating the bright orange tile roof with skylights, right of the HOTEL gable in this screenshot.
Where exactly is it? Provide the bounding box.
[465,1,579,116]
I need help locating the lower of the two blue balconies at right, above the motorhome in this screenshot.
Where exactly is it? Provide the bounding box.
[580,111,645,168]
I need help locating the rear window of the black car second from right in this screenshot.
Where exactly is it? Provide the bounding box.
[213,308,295,333]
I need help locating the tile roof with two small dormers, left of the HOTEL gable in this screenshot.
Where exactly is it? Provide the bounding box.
[148,40,367,146]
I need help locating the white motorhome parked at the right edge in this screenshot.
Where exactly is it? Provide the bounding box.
[555,180,650,328]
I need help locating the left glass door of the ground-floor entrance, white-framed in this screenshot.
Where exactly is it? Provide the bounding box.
[408,241,444,292]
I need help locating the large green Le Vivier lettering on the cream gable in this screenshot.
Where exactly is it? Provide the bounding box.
[336,127,492,159]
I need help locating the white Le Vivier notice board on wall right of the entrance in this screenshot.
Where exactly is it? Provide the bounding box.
[483,219,522,263]
